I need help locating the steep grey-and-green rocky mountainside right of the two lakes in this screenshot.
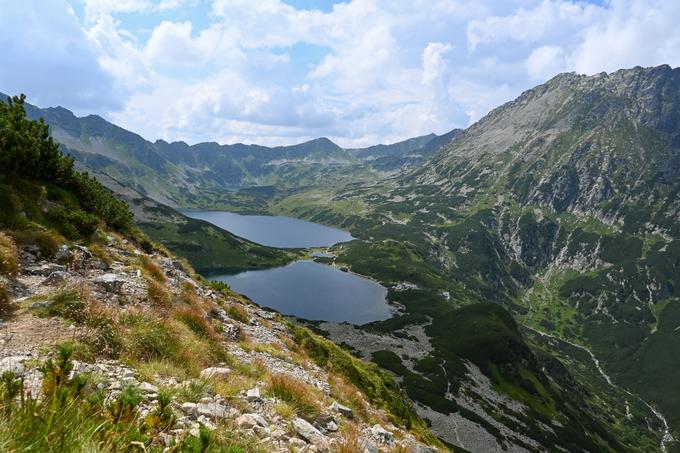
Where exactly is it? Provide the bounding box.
[266,66,680,451]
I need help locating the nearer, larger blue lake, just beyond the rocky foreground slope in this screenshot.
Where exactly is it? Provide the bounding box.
[209,261,391,324]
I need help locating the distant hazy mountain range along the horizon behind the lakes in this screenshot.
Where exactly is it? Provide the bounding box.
[10,93,458,209]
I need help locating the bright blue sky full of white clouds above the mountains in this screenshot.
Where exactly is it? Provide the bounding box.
[0,0,680,147]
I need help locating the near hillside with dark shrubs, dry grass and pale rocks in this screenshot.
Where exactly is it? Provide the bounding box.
[0,91,449,453]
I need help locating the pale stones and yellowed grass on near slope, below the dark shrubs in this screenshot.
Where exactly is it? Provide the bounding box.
[0,233,440,452]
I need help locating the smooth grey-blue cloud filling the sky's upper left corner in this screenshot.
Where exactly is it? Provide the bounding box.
[0,0,122,110]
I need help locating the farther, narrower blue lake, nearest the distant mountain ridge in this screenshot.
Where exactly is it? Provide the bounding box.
[183,211,354,248]
